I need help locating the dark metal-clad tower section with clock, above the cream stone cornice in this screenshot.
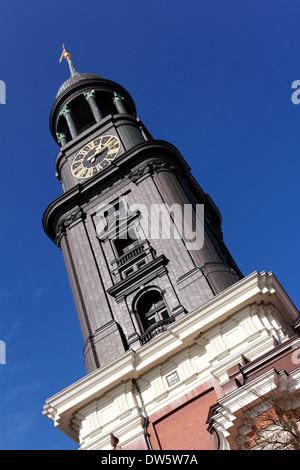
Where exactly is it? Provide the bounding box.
[43,48,242,372]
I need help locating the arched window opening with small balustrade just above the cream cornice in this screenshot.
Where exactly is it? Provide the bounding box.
[134,289,174,344]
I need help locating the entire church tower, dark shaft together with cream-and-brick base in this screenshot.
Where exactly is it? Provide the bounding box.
[43,49,296,449]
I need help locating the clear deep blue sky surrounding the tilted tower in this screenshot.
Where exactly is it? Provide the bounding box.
[0,0,300,450]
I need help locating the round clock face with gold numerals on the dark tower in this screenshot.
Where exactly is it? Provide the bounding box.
[71,135,120,179]
